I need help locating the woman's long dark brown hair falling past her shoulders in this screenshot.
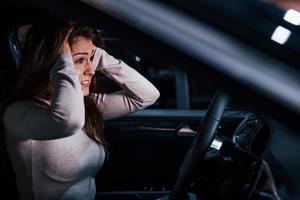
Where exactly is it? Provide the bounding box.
[0,22,106,146]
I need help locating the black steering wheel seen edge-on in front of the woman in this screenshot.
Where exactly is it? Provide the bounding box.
[164,91,229,200]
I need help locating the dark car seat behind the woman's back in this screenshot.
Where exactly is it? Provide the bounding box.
[0,26,22,200]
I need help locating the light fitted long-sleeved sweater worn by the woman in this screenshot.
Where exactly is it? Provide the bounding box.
[4,48,159,200]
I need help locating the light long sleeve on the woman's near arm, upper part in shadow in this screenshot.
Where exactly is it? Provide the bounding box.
[4,54,84,140]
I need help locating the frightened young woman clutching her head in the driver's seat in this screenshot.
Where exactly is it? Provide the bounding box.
[2,23,159,200]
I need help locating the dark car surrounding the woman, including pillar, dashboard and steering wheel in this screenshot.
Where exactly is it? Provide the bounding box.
[0,0,300,200]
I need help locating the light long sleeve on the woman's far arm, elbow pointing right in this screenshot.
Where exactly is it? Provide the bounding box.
[93,48,160,120]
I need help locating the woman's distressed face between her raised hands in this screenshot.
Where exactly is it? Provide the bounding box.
[71,36,96,96]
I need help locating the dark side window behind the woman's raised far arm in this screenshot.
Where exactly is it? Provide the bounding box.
[96,37,214,109]
